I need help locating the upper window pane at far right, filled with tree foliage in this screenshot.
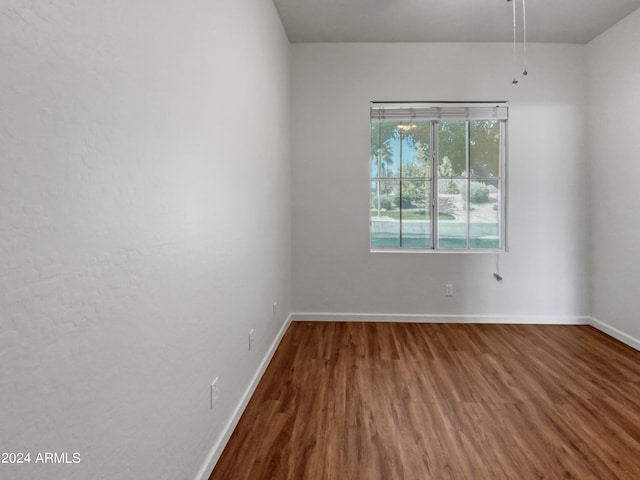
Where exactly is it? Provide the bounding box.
[469,120,500,178]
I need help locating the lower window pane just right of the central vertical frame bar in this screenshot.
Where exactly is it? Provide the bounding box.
[438,179,467,248]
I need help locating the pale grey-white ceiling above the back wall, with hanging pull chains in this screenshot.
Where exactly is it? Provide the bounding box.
[273,0,640,43]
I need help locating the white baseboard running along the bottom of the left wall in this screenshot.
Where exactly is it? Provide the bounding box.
[195,314,291,480]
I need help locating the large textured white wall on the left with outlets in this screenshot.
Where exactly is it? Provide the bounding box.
[0,0,291,480]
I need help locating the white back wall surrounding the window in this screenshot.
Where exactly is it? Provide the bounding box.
[292,44,590,321]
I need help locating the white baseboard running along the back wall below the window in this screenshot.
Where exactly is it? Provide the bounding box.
[291,312,590,325]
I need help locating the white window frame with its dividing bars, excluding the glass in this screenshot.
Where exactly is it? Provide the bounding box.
[369,101,509,253]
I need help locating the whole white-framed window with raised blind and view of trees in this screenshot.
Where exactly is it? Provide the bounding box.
[370,102,508,251]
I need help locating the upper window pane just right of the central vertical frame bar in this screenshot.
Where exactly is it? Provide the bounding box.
[438,122,467,178]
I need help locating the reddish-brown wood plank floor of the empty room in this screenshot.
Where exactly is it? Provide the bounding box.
[210,322,640,480]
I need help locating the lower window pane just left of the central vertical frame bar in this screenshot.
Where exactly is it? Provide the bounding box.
[398,180,431,248]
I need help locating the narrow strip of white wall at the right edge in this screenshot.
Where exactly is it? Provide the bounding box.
[587,10,640,348]
